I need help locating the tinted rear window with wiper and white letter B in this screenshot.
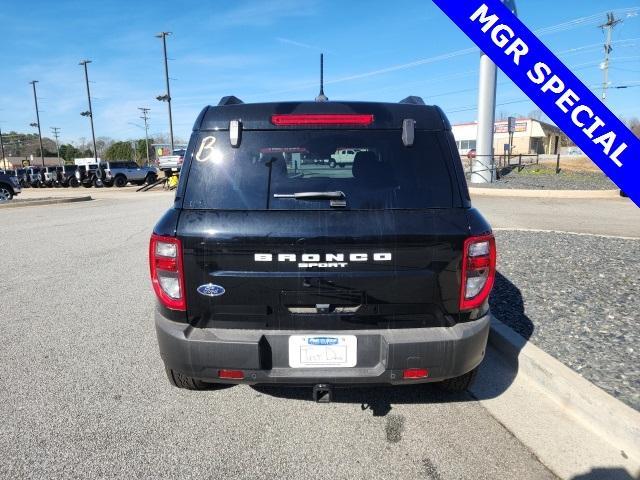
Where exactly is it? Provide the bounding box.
[183,130,459,210]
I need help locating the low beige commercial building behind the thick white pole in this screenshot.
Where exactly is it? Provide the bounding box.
[452,118,570,155]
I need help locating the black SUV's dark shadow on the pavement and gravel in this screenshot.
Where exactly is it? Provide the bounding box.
[252,272,534,416]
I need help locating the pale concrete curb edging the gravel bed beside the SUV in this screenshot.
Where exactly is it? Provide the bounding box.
[489,318,640,461]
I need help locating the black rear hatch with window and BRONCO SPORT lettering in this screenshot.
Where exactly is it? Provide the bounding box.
[177,122,469,330]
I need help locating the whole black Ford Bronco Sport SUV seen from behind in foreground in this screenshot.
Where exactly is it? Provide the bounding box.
[149,97,496,400]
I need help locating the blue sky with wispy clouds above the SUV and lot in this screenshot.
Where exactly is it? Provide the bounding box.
[0,0,640,142]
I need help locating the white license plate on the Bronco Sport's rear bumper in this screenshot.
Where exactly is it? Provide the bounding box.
[289,335,358,368]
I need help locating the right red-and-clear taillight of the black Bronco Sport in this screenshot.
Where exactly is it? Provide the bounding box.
[460,234,496,310]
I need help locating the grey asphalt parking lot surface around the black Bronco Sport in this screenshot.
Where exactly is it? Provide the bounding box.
[0,192,555,479]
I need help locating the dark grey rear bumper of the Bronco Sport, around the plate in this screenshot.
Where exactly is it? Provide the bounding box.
[155,311,491,385]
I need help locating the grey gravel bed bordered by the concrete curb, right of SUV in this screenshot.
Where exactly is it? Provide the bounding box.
[491,231,640,410]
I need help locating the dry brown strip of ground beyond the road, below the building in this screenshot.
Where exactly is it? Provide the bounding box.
[467,165,617,190]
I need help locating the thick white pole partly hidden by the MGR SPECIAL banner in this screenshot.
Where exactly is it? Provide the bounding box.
[471,0,517,183]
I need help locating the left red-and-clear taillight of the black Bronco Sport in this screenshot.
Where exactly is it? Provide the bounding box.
[149,233,186,311]
